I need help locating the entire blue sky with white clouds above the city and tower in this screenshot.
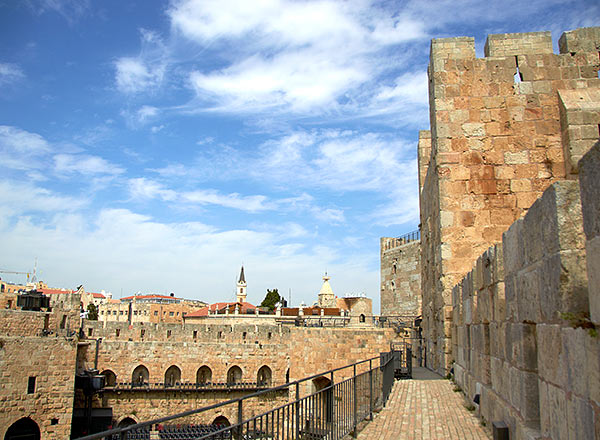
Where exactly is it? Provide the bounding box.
[0,0,600,311]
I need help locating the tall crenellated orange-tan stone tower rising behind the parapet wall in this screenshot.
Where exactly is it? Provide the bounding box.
[419,28,600,372]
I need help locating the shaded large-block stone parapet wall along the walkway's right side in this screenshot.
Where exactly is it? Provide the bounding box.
[451,143,600,440]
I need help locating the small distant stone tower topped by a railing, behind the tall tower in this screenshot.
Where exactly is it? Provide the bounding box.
[380,237,421,316]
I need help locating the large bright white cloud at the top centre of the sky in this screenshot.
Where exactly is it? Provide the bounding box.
[168,0,426,113]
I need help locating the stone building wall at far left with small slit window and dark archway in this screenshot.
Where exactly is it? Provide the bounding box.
[0,310,77,440]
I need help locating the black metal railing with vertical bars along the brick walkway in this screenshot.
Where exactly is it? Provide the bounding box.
[79,351,394,440]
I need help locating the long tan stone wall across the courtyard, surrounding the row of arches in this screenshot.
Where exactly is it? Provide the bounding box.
[78,320,395,423]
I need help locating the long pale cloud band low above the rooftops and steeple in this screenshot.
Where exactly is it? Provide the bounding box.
[0,205,379,304]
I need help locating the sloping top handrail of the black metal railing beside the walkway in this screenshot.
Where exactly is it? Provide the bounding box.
[77,355,391,440]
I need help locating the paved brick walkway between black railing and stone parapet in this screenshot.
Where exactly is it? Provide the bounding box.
[358,372,492,440]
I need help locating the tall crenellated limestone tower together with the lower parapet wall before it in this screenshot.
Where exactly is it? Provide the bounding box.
[418,27,600,439]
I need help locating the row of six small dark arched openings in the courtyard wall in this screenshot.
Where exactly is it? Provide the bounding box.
[101,365,273,387]
